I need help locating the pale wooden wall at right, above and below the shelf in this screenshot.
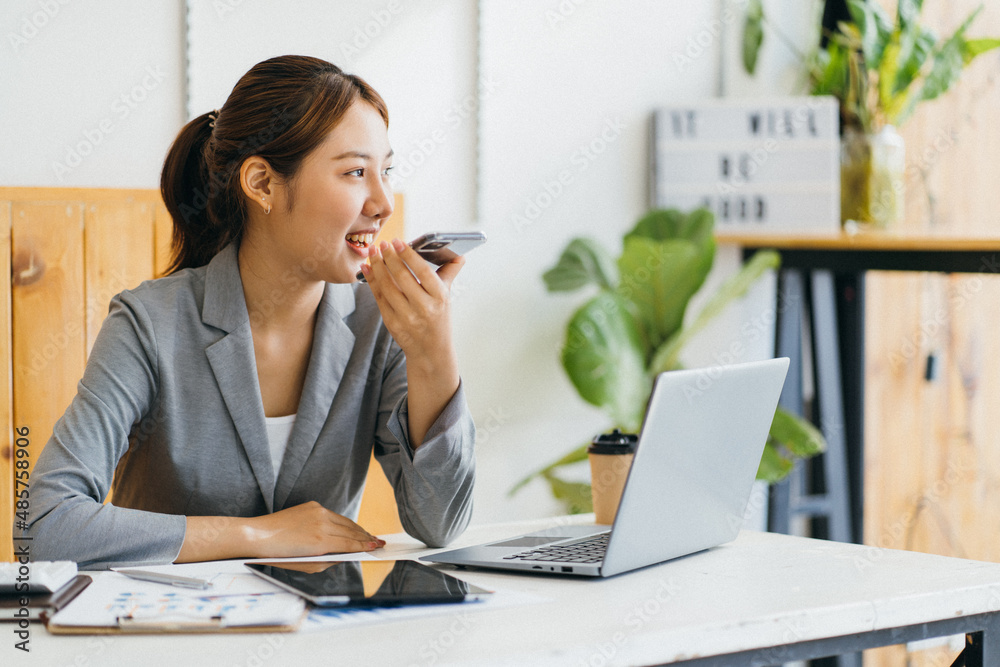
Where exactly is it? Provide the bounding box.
[865,0,1000,667]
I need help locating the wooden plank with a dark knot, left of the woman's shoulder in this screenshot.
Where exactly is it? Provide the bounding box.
[11,202,86,478]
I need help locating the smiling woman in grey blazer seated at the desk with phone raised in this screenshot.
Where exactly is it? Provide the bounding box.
[27,56,475,568]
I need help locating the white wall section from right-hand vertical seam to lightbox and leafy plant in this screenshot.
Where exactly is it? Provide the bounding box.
[468,0,718,519]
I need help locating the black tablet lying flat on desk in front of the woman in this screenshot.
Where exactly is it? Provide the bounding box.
[245,560,492,607]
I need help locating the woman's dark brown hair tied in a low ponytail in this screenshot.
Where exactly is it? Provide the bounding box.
[160,56,389,274]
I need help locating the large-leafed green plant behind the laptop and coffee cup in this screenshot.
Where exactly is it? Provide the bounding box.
[511,209,826,513]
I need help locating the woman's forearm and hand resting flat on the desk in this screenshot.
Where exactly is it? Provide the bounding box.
[174,501,385,563]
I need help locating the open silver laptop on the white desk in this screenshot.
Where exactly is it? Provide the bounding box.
[421,358,788,577]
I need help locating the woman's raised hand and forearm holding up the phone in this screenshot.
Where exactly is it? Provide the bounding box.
[362,239,465,448]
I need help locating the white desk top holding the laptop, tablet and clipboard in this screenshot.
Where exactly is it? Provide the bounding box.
[0,517,1000,667]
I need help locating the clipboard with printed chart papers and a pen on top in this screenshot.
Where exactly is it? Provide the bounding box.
[46,573,308,635]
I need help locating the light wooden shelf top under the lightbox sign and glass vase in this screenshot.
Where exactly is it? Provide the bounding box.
[715,232,1000,252]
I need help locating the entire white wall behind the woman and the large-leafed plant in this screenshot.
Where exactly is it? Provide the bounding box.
[0,0,794,521]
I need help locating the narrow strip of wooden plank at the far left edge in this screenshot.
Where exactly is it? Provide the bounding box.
[0,201,11,562]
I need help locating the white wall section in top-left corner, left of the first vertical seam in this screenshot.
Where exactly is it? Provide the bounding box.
[0,0,184,188]
